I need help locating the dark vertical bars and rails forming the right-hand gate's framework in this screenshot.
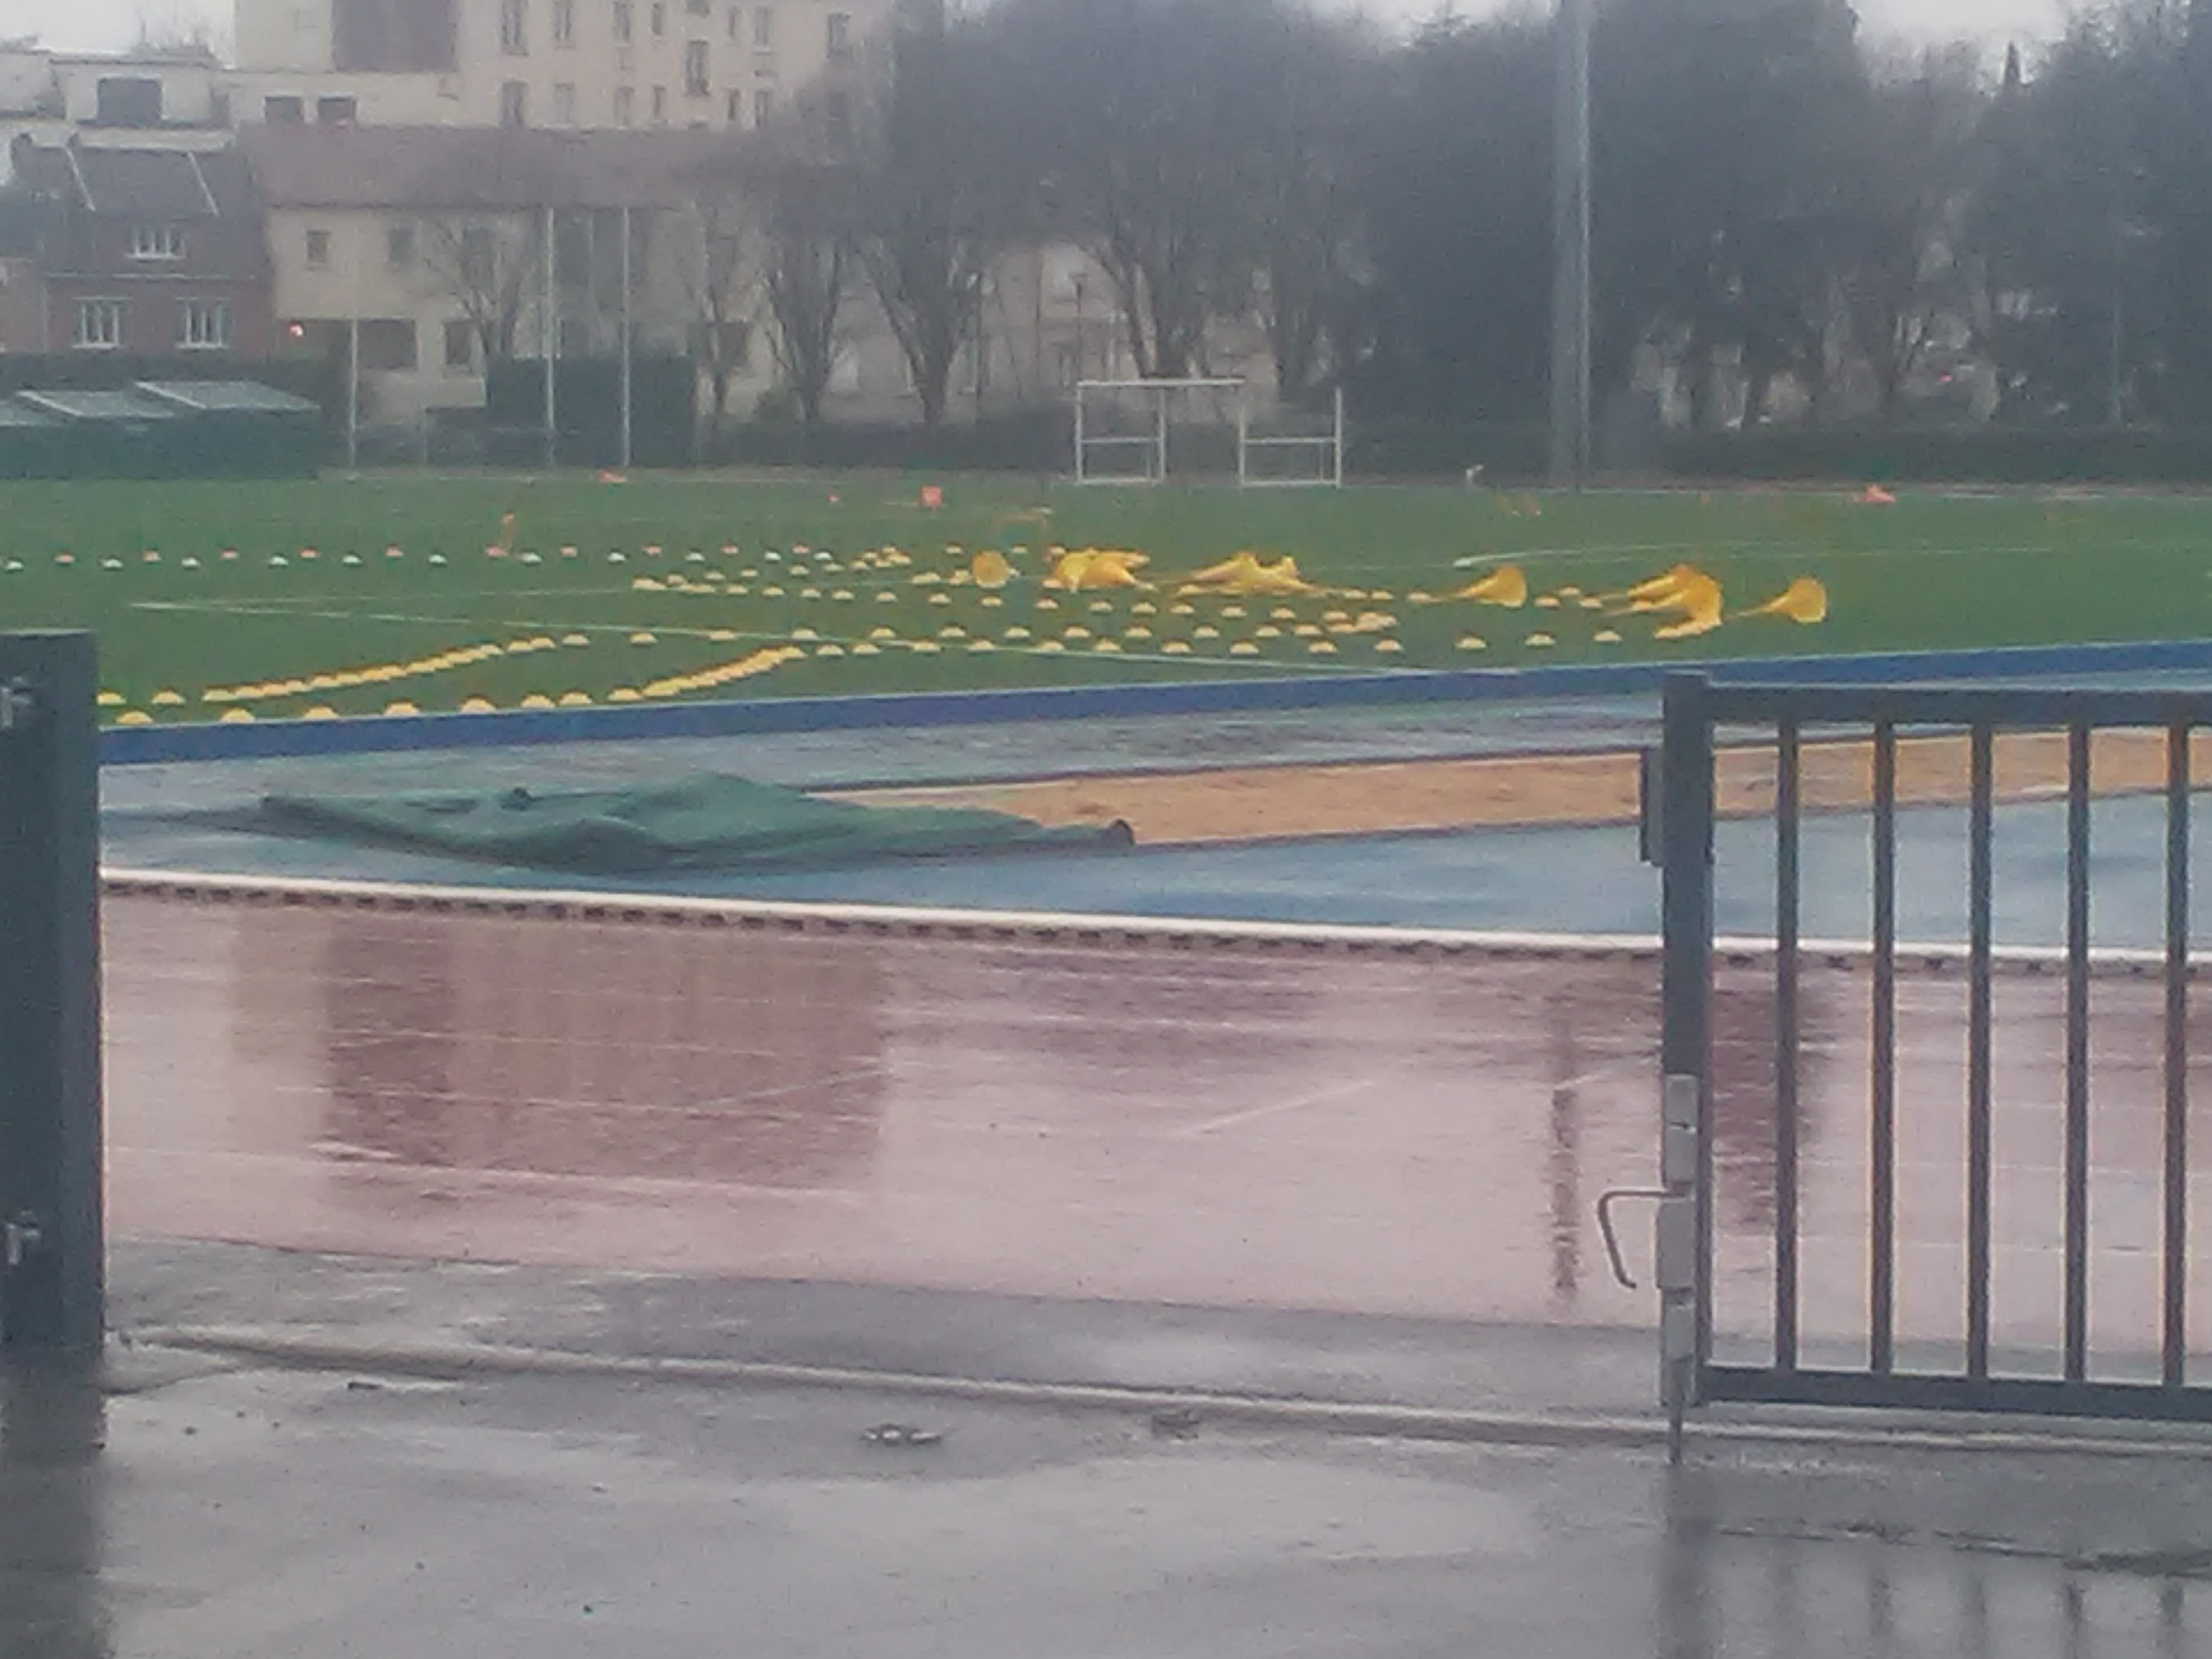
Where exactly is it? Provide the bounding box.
[1666,684,2212,1422]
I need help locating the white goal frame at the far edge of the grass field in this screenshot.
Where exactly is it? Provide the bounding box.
[1075,378,1345,489]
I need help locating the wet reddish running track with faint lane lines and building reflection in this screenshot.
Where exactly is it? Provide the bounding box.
[106,894,2212,1376]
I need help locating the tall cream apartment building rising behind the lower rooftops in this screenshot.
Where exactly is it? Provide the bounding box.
[220,0,898,131]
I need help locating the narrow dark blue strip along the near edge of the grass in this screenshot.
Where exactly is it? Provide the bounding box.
[100,639,2212,765]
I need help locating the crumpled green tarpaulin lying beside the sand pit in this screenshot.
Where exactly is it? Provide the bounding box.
[250,774,1132,876]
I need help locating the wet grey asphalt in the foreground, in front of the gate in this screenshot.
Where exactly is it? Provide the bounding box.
[0,1369,2212,1659]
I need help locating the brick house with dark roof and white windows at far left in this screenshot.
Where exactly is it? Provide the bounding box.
[0,140,276,361]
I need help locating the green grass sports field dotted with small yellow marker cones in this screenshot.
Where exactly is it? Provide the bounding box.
[0,476,2212,723]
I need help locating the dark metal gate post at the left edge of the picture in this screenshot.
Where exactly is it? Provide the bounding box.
[0,633,104,1351]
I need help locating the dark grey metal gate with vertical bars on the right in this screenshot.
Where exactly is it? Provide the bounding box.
[1645,675,2212,1431]
